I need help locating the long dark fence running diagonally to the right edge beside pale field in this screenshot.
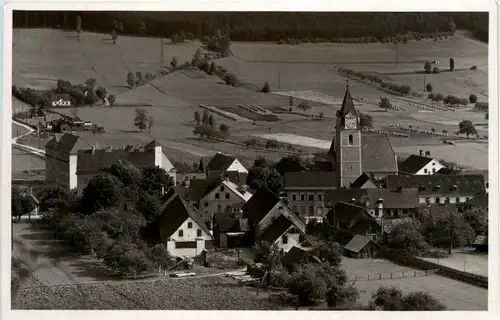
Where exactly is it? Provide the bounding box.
[381,248,488,288]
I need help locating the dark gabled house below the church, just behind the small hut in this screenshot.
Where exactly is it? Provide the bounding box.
[327,201,382,237]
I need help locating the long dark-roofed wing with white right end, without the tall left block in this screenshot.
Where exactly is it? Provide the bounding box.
[76,140,176,194]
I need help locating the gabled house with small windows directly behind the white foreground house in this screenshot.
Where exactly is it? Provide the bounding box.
[188,176,252,229]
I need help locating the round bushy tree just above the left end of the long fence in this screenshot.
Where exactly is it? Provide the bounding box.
[387,222,429,255]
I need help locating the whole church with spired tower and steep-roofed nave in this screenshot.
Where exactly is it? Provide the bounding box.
[328,85,398,188]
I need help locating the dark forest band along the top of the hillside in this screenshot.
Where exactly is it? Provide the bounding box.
[13,11,488,42]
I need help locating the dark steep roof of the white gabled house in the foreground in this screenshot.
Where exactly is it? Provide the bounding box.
[159,195,211,240]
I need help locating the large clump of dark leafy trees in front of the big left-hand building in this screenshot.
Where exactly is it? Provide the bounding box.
[39,163,173,276]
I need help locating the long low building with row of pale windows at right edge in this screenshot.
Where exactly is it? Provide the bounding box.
[387,175,486,204]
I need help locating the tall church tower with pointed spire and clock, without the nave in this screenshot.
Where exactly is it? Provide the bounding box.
[335,84,363,188]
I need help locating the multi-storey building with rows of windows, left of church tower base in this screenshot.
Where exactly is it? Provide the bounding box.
[283,171,337,222]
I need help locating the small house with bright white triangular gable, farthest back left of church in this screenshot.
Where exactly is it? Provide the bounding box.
[205,152,248,185]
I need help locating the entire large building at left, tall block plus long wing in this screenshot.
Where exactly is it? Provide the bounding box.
[45,133,175,193]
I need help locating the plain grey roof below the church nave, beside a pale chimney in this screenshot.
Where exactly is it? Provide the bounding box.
[366,188,420,209]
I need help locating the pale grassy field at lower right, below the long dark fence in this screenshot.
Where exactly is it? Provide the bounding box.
[342,257,488,311]
